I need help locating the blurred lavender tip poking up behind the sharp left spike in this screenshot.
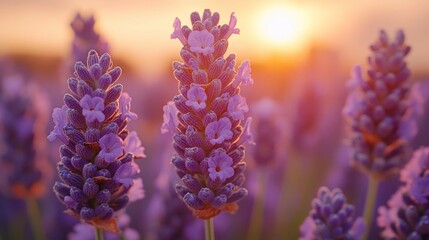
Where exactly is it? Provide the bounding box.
[70,13,109,63]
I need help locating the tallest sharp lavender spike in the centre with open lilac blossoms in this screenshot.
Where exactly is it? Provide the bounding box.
[166,9,253,219]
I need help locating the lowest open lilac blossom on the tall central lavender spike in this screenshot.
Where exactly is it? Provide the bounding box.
[208,151,234,182]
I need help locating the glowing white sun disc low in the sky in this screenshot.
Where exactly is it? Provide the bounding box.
[258,5,304,47]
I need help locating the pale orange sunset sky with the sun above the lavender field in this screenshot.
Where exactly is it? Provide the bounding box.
[0,0,429,78]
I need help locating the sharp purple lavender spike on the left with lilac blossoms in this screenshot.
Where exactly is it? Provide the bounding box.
[48,50,144,233]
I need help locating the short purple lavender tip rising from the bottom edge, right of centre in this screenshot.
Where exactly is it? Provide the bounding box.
[300,187,365,240]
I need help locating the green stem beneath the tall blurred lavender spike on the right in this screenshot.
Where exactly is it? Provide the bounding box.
[362,176,378,239]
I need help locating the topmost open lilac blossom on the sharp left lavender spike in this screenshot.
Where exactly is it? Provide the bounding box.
[79,94,105,122]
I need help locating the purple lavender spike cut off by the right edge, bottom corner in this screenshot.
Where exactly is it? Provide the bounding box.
[377,147,429,240]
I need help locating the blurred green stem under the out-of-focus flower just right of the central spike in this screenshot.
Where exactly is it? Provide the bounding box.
[247,172,265,240]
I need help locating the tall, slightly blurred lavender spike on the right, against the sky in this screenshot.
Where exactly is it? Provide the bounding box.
[344,31,416,179]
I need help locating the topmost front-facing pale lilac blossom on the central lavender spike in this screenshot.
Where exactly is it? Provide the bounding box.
[188,29,214,55]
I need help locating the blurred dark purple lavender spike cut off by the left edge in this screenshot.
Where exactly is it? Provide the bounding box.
[0,76,52,198]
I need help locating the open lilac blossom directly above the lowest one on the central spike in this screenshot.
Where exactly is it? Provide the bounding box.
[205,117,232,144]
